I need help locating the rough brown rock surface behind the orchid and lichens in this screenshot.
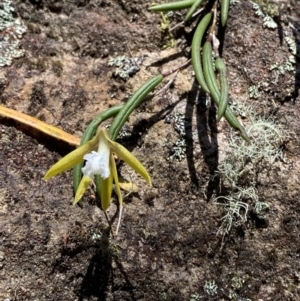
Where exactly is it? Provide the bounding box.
[0,0,300,301]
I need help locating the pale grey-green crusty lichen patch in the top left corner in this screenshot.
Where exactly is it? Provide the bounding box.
[0,0,27,67]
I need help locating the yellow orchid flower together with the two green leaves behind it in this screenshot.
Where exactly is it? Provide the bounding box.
[44,75,163,233]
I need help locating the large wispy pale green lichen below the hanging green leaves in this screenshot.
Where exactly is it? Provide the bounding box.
[215,105,289,235]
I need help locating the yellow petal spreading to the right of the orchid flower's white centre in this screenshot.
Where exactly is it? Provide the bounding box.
[102,131,151,185]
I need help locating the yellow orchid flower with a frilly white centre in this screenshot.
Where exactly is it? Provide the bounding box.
[44,128,151,233]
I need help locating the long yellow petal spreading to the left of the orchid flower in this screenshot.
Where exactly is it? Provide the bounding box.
[44,136,98,180]
